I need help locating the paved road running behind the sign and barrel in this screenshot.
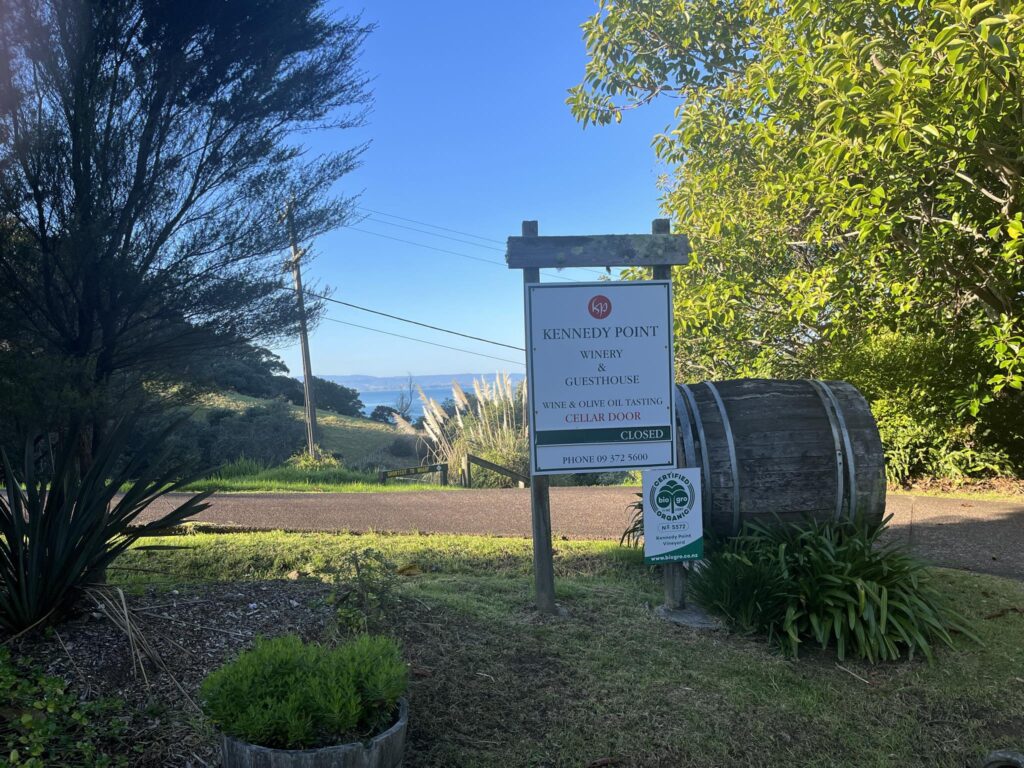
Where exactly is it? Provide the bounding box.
[142,487,1024,579]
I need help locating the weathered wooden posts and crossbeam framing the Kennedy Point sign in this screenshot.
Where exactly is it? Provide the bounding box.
[506,219,690,613]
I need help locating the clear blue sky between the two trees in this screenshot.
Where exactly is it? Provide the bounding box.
[275,0,672,376]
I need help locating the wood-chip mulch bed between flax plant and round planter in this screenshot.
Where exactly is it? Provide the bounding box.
[10,580,334,768]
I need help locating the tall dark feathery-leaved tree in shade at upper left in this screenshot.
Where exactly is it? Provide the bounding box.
[0,0,369,454]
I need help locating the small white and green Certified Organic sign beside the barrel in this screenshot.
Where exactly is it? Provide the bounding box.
[643,469,703,563]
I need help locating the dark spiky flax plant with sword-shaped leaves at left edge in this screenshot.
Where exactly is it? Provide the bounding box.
[0,421,209,633]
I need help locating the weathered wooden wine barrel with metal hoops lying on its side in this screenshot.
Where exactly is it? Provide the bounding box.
[676,379,886,536]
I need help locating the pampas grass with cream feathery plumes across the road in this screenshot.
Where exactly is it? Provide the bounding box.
[420,374,529,485]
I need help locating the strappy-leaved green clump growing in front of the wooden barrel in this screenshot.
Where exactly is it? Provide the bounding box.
[691,518,976,663]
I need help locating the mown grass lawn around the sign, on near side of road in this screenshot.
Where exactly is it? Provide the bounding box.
[92,534,1024,768]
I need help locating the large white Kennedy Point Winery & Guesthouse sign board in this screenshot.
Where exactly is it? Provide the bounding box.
[526,281,676,475]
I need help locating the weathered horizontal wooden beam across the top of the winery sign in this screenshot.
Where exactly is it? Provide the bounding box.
[505,219,690,269]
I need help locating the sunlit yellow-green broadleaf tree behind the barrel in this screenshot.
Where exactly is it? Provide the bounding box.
[568,0,1024,475]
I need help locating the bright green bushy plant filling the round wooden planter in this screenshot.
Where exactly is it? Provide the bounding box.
[200,635,408,750]
